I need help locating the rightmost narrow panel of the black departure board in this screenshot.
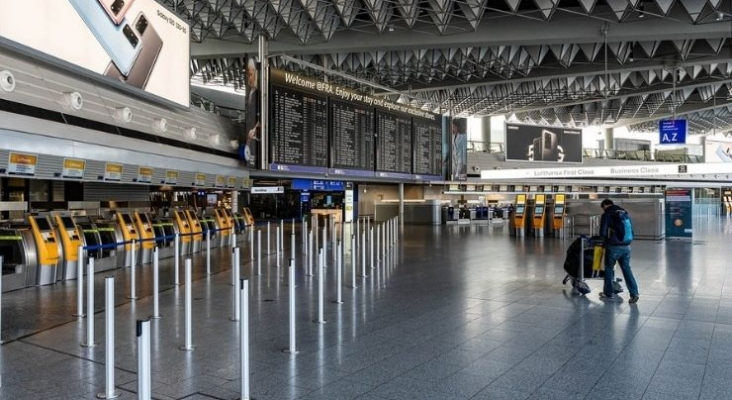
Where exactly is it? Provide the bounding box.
[412,118,442,175]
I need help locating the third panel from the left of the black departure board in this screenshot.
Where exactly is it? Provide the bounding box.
[376,112,412,174]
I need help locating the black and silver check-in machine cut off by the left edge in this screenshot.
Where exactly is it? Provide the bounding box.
[0,229,38,292]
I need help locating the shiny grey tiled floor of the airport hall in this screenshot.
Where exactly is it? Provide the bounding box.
[0,220,732,400]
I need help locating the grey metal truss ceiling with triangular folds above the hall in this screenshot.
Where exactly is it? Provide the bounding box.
[174,0,732,133]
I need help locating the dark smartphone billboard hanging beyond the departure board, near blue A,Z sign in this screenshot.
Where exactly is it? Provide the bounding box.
[506,124,582,163]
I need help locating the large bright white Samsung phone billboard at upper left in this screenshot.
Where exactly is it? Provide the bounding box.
[0,0,190,107]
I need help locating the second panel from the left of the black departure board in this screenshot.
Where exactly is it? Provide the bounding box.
[330,100,376,171]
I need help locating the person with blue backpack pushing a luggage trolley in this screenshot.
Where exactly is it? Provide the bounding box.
[600,199,640,304]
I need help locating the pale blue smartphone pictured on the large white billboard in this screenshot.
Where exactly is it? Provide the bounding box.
[69,0,142,76]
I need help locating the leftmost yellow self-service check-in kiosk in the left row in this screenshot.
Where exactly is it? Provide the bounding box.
[28,215,60,285]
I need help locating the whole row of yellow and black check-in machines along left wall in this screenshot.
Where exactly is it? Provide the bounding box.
[0,208,254,292]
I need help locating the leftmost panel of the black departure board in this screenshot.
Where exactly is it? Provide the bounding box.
[270,85,328,167]
